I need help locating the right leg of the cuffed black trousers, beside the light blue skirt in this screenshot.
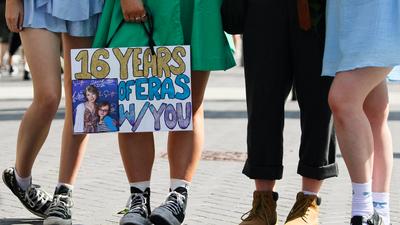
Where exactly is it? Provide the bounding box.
[289,1,338,180]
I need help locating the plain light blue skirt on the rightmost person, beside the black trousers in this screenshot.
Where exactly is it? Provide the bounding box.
[322,0,400,76]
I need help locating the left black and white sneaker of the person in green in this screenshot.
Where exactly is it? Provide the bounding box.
[119,187,152,225]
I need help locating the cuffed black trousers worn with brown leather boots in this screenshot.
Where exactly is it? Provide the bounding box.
[243,0,338,180]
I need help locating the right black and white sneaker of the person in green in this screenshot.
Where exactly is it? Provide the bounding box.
[150,187,188,225]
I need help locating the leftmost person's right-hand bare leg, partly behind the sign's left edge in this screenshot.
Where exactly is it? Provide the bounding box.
[57,34,92,185]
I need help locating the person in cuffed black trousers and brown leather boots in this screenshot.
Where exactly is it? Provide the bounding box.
[240,0,338,225]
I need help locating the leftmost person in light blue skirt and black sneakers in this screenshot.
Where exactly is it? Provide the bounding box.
[2,0,103,225]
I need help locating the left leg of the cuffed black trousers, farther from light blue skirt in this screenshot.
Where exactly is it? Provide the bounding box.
[243,0,292,180]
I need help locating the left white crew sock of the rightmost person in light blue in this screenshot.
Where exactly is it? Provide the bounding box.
[351,182,374,217]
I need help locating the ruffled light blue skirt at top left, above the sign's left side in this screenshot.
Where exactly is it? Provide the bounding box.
[23,0,104,37]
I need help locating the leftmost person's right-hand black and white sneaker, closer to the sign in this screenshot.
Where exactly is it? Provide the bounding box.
[43,185,74,225]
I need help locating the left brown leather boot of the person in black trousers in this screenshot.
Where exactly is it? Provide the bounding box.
[239,191,278,225]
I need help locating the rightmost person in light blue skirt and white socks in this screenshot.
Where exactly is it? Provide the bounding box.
[322,0,400,225]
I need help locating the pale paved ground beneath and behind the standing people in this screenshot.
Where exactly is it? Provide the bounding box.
[0,67,400,225]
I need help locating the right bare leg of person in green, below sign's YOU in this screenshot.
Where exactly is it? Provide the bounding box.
[168,71,210,181]
